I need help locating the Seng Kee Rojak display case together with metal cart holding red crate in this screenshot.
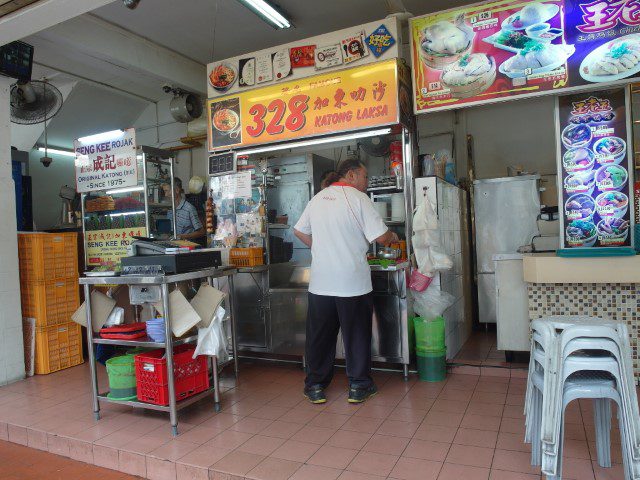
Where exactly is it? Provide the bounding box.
[72,129,238,435]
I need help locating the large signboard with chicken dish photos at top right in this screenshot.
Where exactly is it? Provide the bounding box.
[410,0,640,113]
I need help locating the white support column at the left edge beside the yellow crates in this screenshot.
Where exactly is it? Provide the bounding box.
[0,76,25,385]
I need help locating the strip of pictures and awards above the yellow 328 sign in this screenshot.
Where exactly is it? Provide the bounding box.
[207,17,400,98]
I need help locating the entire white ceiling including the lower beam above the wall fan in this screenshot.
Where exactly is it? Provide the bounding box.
[13,0,472,152]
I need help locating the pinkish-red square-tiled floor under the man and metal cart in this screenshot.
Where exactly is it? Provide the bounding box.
[0,364,623,480]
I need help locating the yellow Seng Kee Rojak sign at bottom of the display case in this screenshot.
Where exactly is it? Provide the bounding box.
[85,227,147,267]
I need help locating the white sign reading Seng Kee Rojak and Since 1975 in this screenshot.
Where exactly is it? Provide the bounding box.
[73,128,138,193]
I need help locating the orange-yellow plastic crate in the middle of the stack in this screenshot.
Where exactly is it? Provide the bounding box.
[20,279,80,327]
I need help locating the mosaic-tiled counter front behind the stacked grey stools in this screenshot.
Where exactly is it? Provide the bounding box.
[528,283,640,382]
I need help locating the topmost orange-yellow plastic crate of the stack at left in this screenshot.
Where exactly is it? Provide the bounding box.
[18,232,78,283]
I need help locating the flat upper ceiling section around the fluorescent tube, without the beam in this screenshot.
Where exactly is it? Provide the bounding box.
[92,0,473,64]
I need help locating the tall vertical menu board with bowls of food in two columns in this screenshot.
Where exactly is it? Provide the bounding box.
[557,88,633,248]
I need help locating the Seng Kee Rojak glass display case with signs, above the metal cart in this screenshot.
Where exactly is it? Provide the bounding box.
[75,135,176,268]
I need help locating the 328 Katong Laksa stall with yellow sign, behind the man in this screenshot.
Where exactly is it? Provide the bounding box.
[207,18,415,375]
